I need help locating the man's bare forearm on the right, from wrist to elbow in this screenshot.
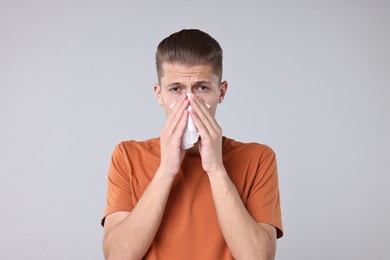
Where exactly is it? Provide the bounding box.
[209,169,275,259]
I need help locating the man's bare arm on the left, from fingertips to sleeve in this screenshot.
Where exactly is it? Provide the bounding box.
[103,94,188,259]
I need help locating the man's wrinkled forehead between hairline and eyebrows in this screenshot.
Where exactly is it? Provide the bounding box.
[161,63,218,84]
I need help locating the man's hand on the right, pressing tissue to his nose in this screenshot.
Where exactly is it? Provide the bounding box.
[190,95,224,175]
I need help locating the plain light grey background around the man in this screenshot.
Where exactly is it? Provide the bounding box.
[0,0,390,260]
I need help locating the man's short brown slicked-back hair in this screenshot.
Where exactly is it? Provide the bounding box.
[156,29,222,81]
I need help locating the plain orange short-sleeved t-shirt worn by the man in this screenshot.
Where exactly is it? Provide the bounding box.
[102,137,283,260]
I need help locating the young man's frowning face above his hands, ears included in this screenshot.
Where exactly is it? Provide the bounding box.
[154,63,227,116]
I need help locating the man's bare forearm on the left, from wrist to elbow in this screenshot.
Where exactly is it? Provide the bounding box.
[103,170,174,259]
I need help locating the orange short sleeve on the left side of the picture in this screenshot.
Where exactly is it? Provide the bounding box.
[101,144,134,226]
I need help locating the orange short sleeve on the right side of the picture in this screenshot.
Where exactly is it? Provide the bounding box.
[246,152,283,238]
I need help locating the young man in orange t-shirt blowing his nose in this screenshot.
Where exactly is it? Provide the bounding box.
[102,30,283,259]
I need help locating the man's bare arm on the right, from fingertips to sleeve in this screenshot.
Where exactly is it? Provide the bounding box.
[191,96,276,259]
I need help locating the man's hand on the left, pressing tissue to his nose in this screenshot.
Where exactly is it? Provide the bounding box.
[160,95,189,176]
